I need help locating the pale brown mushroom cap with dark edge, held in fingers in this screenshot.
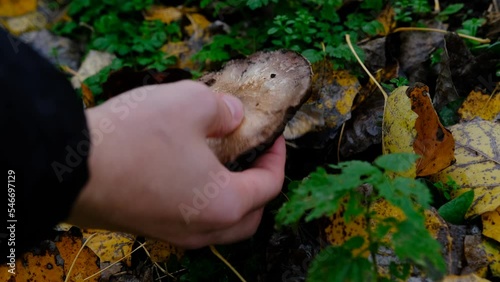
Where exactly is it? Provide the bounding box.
[200,50,312,164]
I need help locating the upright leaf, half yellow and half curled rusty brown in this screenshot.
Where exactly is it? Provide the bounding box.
[383,83,455,177]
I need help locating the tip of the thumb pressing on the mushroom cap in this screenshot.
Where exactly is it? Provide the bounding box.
[206,93,244,137]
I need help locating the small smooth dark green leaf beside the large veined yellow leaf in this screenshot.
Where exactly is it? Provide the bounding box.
[438,190,474,224]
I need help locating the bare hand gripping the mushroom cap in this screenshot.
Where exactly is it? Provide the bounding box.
[67,81,286,248]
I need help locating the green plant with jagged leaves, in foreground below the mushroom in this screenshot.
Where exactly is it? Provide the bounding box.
[276,153,446,281]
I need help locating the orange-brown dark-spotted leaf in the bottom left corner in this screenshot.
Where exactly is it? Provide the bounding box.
[0,232,100,281]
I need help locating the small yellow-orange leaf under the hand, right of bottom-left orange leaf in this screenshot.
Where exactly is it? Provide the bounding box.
[82,229,135,266]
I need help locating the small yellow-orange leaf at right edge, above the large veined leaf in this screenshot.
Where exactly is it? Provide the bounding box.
[458,91,500,121]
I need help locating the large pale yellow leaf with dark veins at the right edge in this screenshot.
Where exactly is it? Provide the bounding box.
[431,119,500,218]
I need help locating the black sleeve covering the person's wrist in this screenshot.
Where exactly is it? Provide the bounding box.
[0,28,90,261]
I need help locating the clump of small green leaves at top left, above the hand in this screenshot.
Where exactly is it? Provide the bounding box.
[53,0,182,71]
